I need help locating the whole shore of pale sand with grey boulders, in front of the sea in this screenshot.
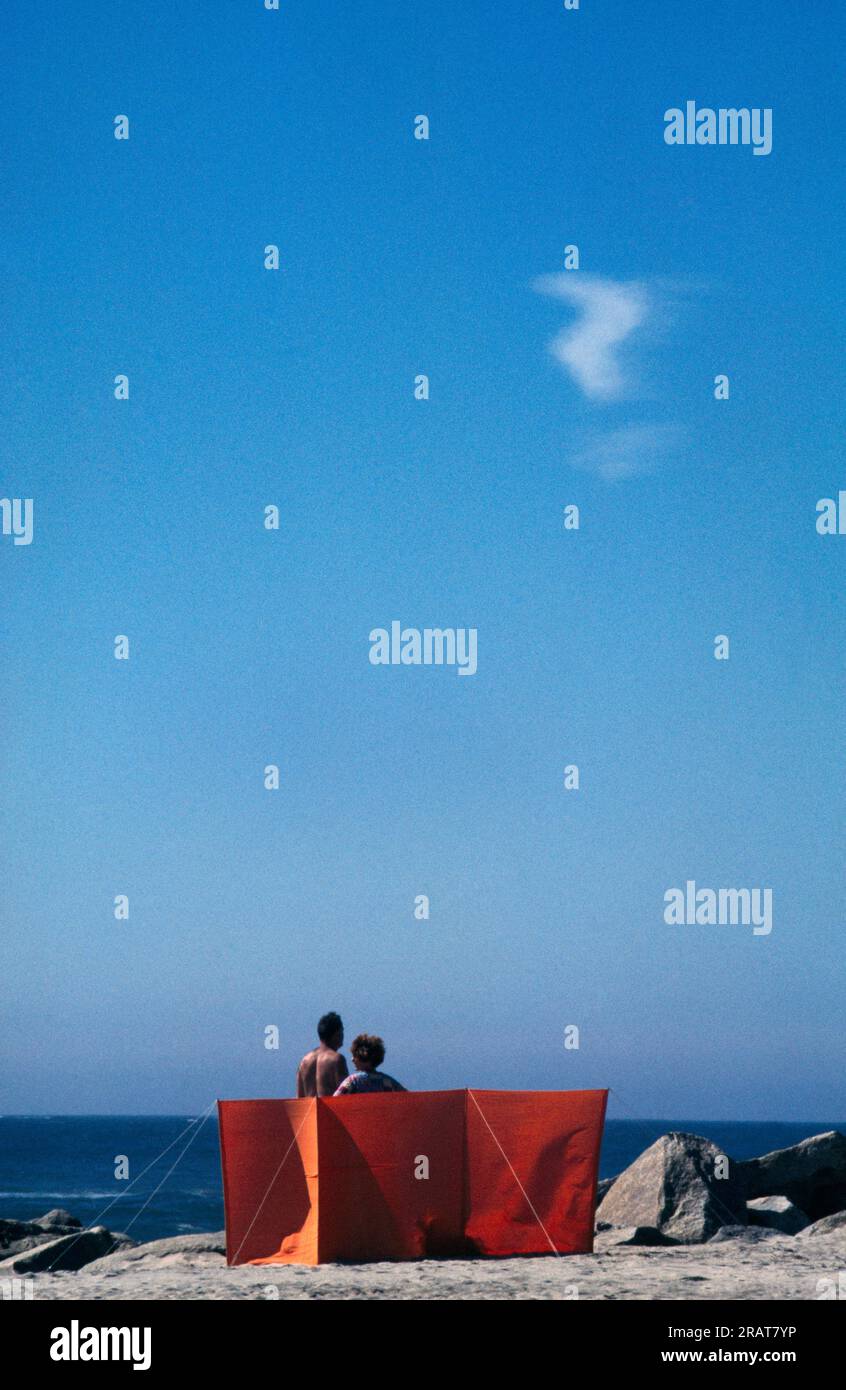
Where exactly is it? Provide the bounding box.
[8,1130,846,1302]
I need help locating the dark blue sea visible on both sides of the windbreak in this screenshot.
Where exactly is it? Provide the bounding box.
[0,1112,846,1241]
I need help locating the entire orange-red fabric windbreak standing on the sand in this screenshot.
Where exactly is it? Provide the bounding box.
[219,1091,607,1265]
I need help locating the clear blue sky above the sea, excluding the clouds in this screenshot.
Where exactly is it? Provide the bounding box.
[0,0,846,1119]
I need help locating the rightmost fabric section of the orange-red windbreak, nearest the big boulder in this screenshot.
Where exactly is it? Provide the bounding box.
[467,1091,608,1255]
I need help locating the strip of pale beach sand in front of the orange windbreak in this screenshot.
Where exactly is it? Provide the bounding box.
[14,1230,846,1301]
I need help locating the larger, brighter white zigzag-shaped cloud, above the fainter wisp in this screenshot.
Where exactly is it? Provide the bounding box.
[533,271,650,400]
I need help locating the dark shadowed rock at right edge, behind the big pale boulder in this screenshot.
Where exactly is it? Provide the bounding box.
[735,1130,846,1222]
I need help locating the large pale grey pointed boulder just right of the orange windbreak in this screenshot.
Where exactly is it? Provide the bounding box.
[596,1133,746,1243]
